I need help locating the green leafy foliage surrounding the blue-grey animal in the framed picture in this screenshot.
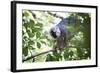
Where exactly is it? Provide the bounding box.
[22,10,91,63]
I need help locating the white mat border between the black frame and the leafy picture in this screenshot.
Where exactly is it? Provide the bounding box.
[16,4,96,70]
